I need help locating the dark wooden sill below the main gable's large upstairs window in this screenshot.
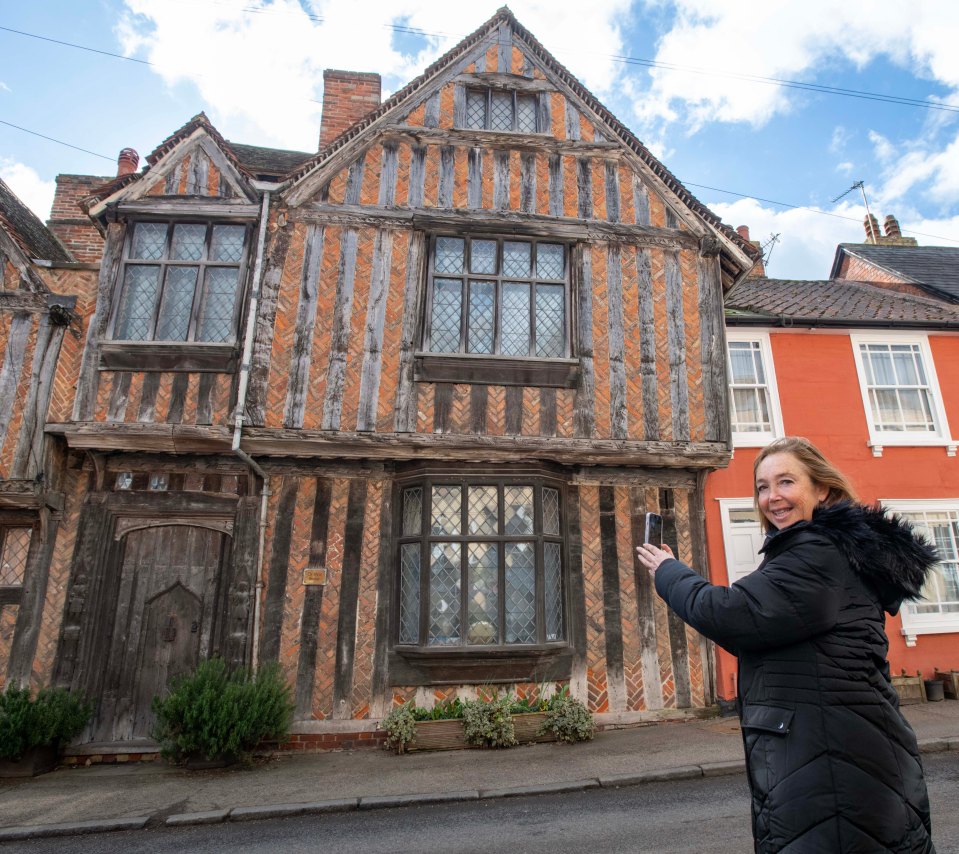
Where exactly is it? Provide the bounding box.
[413,353,579,388]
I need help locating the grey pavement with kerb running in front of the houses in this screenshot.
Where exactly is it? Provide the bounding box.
[0,701,959,842]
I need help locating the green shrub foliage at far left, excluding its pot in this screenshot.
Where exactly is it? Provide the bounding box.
[0,684,93,761]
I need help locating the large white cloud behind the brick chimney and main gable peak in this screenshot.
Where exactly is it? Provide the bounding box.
[116,0,633,150]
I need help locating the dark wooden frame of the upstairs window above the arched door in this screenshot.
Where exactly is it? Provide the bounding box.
[104,221,252,348]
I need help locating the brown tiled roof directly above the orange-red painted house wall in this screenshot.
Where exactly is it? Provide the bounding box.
[725,278,959,326]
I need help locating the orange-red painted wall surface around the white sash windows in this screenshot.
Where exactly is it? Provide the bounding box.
[706,330,959,699]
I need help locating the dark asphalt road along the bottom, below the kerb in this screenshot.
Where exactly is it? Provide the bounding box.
[3,751,959,854]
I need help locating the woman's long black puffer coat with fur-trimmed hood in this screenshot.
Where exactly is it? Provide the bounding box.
[656,503,936,854]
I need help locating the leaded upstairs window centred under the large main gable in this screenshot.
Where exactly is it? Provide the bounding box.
[424,236,569,359]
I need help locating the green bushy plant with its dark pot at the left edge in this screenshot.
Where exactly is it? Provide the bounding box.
[0,684,93,777]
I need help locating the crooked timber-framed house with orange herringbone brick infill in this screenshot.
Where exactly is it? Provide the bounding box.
[0,9,758,750]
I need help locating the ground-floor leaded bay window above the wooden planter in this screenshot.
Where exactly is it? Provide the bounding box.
[397,478,566,648]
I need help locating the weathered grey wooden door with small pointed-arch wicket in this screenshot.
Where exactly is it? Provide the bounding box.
[90,524,227,742]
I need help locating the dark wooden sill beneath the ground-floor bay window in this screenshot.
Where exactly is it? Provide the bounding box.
[389,641,573,685]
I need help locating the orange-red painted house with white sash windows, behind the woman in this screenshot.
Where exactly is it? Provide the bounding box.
[705,227,959,699]
